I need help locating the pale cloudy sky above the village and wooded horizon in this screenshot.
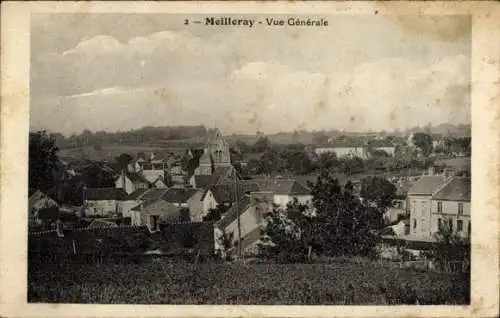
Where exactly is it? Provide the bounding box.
[31,14,471,134]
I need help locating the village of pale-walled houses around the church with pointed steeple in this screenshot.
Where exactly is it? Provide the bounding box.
[28,128,471,266]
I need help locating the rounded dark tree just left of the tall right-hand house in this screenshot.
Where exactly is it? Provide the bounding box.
[360,176,397,212]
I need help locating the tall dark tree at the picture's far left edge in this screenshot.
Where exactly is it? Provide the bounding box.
[28,131,59,191]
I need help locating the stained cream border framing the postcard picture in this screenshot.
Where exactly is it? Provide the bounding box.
[0,1,500,317]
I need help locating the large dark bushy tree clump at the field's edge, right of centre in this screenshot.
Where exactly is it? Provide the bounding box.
[260,173,383,262]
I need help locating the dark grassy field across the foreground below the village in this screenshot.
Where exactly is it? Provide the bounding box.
[28,258,469,305]
